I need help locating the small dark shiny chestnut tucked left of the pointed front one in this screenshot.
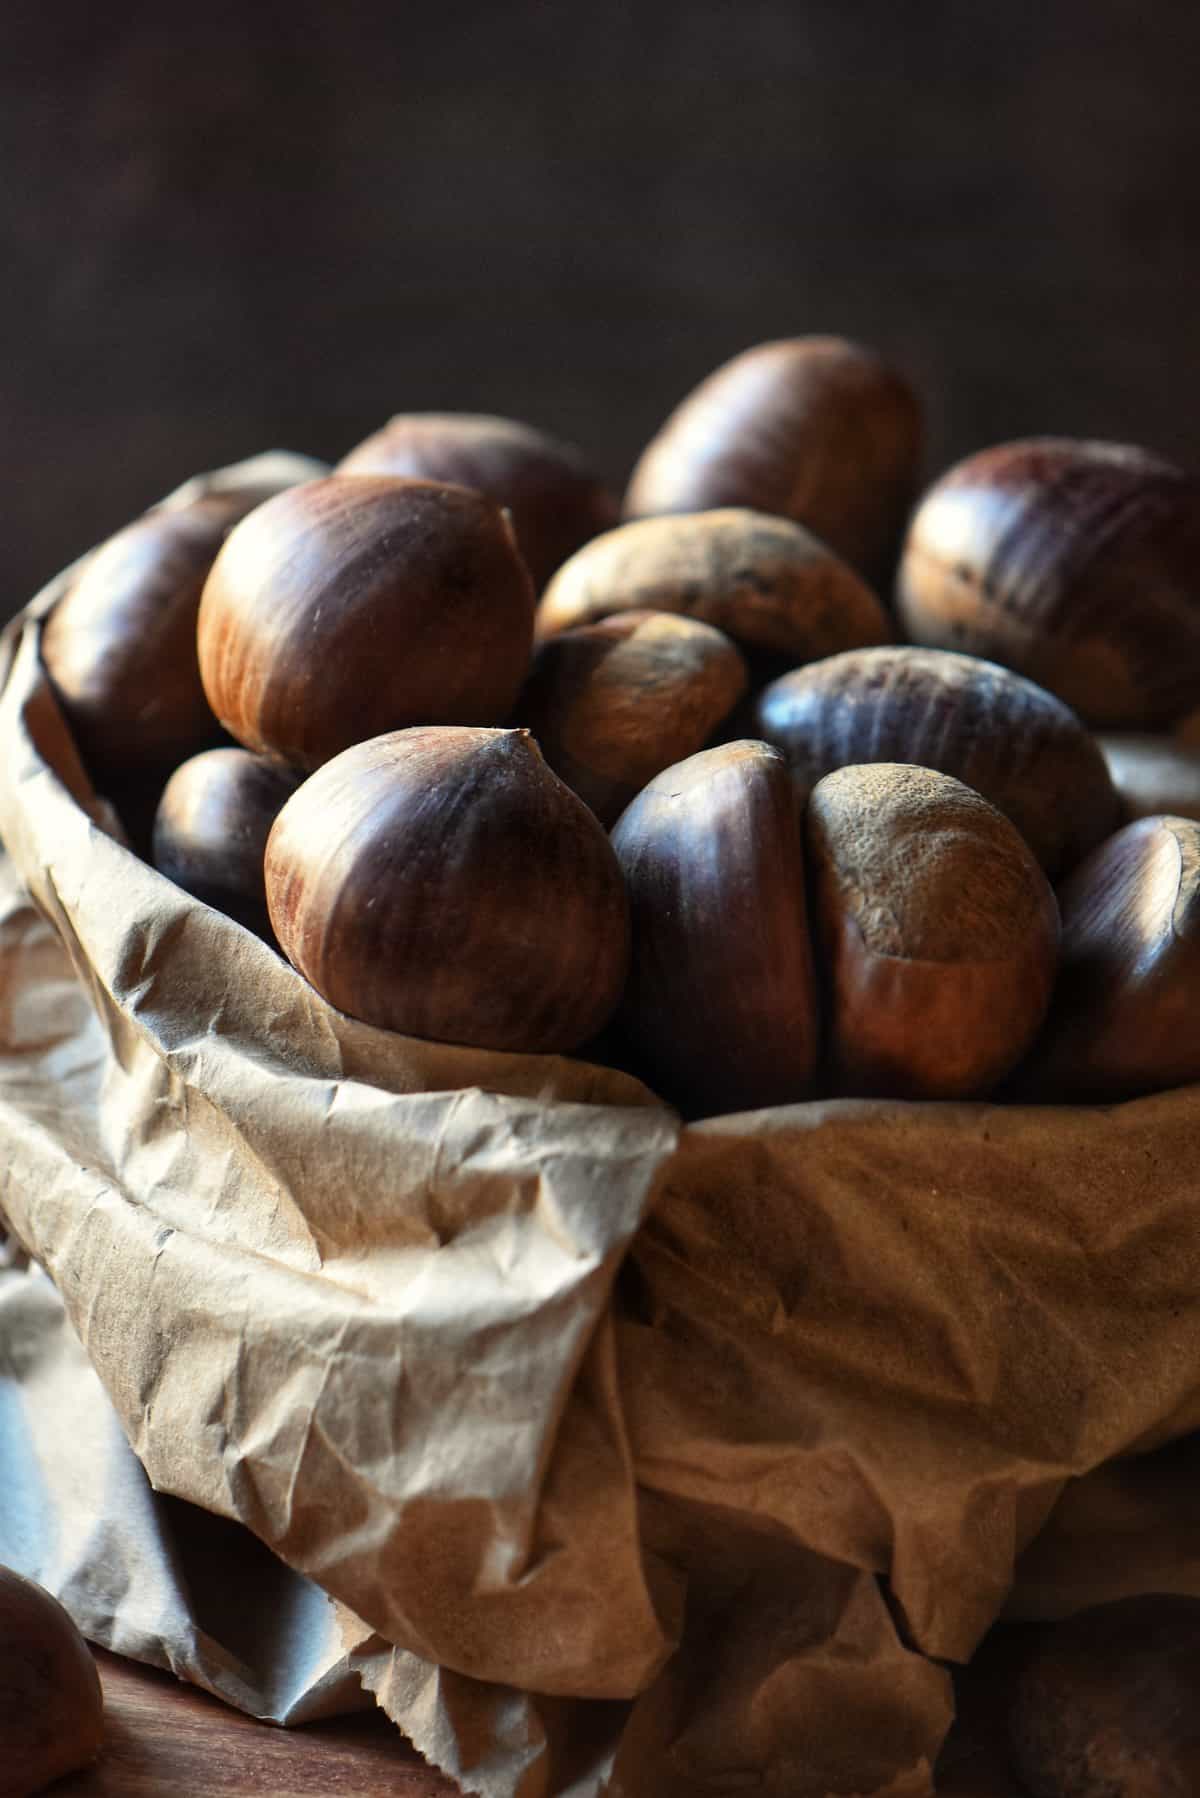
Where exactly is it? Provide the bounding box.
[151,748,300,935]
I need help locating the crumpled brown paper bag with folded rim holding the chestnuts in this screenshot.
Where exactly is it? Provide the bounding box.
[0,456,1200,1798]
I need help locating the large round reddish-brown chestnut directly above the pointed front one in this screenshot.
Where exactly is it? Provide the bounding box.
[196,475,534,770]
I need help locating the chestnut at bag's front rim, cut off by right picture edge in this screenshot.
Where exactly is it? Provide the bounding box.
[1029,816,1200,1099]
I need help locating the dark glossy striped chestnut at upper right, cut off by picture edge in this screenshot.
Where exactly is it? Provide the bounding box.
[896,437,1200,730]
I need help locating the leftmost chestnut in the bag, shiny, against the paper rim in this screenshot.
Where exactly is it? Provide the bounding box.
[41,496,245,780]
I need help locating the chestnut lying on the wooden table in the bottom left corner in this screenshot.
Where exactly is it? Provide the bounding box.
[0,1568,104,1798]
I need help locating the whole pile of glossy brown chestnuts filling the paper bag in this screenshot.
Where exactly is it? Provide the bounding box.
[32,338,1200,1115]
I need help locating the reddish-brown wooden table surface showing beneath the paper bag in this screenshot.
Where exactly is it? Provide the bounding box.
[50,1651,1022,1798]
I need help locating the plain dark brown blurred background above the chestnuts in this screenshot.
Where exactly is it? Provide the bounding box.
[0,0,1200,611]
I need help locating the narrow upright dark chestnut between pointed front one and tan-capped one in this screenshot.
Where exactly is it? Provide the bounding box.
[612,743,817,1115]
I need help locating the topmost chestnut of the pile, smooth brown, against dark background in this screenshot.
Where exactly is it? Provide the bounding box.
[624,336,921,581]
